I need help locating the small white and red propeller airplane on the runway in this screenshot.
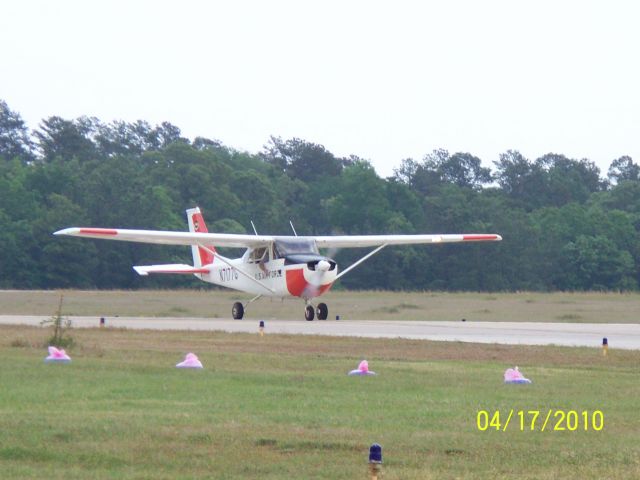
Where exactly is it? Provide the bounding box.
[54,207,502,321]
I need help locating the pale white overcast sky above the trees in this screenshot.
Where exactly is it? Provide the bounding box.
[0,0,640,176]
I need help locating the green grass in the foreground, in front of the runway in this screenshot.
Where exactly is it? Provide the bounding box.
[0,327,640,480]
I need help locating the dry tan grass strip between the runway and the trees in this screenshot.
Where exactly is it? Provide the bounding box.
[0,290,640,323]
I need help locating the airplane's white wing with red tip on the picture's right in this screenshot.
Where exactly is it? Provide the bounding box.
[315,233,502,248]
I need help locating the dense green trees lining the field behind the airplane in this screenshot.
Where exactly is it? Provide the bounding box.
[0,101,640,290]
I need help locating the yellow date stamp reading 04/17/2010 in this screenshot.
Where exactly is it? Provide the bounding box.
[476,409,604,432]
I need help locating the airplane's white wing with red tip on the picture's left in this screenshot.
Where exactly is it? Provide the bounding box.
[54,227,274,248]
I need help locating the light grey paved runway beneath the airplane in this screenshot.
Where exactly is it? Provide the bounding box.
[0,315,640,350]
